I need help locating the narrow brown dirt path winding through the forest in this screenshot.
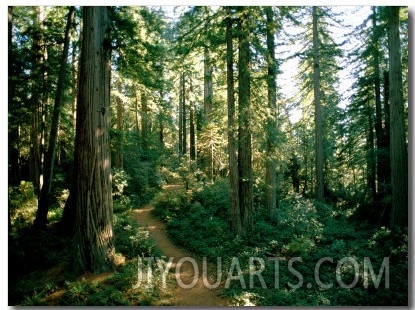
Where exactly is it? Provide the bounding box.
[133,185,229,306]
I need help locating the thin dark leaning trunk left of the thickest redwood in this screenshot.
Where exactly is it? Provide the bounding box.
[34,6,75,229]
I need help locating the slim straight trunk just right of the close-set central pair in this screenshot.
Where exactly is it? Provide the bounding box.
[265,6,278,216]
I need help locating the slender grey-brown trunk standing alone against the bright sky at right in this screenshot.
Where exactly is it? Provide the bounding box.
[313,6,324,201]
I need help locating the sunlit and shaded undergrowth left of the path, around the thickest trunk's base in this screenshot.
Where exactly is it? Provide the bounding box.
[9,172,172,306]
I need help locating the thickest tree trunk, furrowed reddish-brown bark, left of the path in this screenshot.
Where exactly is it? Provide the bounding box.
[74,6,114,273]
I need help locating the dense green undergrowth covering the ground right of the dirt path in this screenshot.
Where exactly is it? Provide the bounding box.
[154,180,408,306]
